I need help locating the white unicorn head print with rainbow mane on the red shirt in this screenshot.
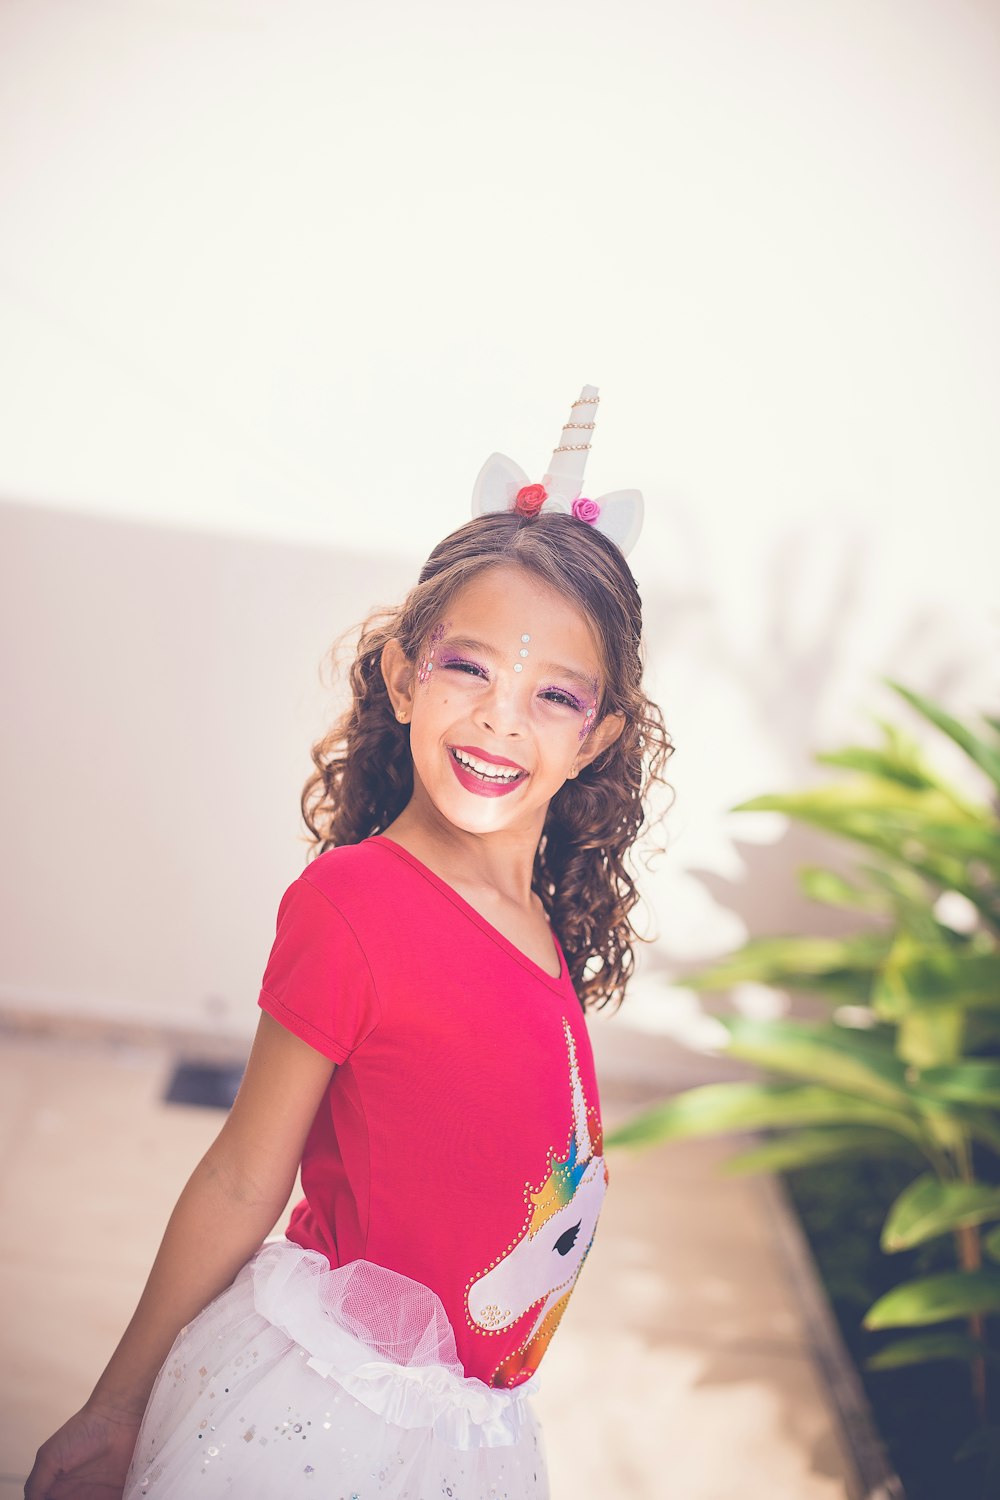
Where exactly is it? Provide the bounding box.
[465,1019,607,1386]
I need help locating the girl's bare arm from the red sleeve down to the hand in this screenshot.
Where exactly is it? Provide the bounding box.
[25,1013,334,1500]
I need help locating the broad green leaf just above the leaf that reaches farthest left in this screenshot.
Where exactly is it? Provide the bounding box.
[720,1016,912,1110]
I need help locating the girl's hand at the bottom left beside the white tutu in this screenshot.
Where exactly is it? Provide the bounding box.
[24,1406,142,1500]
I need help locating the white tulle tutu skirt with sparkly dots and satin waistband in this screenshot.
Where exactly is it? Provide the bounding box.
[123,1241,549,1500]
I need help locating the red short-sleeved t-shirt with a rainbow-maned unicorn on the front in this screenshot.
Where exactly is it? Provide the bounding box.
[259,836,607,1386]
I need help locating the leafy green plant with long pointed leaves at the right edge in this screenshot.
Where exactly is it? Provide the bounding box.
[607,680,1000,1451]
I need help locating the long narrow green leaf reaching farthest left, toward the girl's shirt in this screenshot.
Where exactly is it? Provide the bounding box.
[604,1082,925,1146]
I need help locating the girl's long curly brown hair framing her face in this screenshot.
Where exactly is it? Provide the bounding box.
[301,512,675,1008]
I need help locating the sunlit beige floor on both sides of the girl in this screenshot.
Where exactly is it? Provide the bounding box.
[0,1022,863,1500]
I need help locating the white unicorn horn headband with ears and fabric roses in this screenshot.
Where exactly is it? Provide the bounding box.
[472,386,643,554]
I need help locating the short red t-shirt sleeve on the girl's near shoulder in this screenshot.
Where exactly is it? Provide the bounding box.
[258,875,379,1062]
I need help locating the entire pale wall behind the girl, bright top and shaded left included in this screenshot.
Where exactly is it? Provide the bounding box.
[0,0,1000,1044]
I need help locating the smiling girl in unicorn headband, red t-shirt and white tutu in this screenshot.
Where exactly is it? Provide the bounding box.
[25,387,673,1500]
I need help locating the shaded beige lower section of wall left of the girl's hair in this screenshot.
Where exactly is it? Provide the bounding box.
[0,504,414,1032]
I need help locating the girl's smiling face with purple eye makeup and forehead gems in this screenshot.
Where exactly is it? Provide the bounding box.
[382,566,622,839]
